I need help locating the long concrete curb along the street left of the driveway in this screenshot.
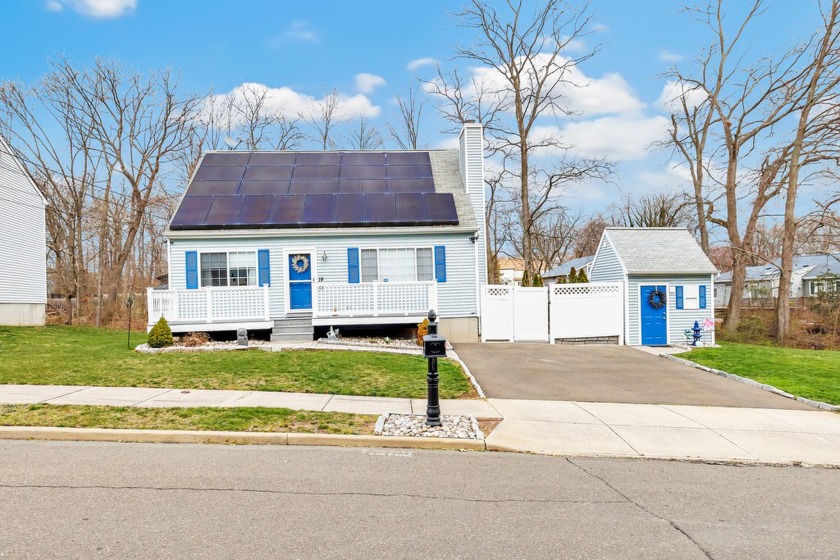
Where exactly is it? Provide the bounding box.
[0,426,486,451]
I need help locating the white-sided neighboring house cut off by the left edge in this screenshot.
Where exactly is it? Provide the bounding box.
[0,136,47,325]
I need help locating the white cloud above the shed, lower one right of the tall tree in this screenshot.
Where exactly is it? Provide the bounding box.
[534,115,668,161]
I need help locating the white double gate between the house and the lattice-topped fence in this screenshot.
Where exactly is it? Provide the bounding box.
[481,285,548,342]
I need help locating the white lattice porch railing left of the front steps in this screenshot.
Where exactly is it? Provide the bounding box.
[147,286,269,325]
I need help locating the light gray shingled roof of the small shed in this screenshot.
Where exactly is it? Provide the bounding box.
[604,227,717,274]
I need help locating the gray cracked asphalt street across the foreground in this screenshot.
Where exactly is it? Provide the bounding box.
[0,441,840,559]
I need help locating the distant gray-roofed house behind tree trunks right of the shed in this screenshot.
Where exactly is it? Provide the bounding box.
[715,253,840,307]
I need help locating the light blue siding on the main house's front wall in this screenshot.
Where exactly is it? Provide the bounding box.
[169,232,478,319]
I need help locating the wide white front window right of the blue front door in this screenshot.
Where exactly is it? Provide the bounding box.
[361,247,434,282]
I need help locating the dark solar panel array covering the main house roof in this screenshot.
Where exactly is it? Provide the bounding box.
[170,152,458,229]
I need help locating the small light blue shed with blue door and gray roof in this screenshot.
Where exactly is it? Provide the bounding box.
[590,227,717,346]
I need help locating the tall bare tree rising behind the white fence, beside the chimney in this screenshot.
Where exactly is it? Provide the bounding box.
[434,0,609,284]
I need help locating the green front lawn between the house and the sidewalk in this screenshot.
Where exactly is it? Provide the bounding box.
[0,326,473,399]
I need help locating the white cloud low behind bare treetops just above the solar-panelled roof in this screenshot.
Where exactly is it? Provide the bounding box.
[206,82,382,125]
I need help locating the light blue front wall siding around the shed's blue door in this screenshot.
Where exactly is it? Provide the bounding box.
[627,274,715,346]
